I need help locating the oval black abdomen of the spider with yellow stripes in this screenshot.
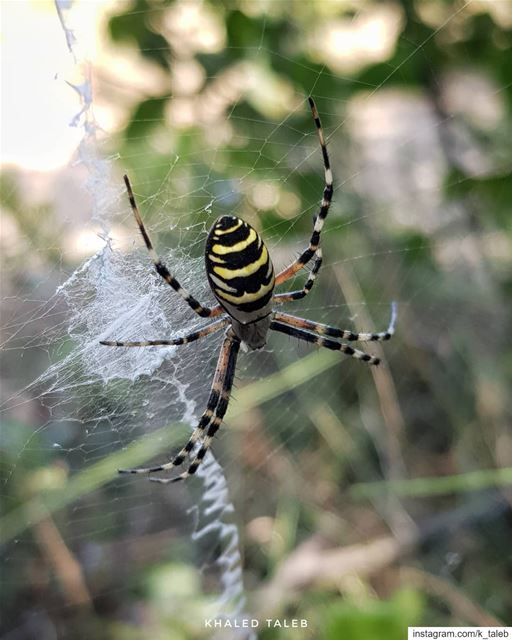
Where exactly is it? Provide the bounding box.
[205,216,275,324]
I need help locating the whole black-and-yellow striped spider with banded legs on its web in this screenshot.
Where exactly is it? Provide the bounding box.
[101,97,396,484]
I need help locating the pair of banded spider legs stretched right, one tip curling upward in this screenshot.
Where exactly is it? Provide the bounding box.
[270,302,396,365]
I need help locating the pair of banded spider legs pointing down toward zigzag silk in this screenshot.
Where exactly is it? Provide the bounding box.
[119,329,240,484]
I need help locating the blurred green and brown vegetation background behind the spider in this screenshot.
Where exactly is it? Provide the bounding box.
[0,0,512,640]
